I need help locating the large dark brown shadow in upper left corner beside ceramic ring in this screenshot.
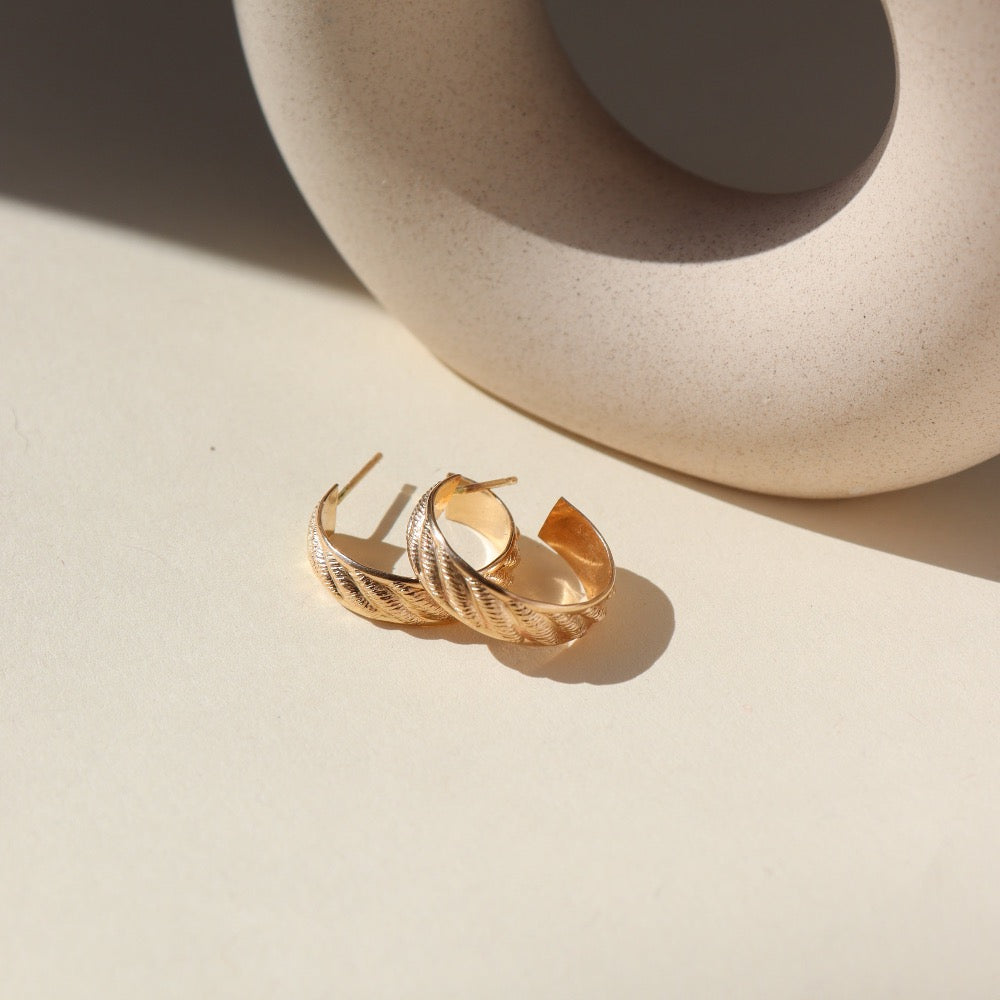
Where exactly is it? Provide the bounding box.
[0,0,361,291]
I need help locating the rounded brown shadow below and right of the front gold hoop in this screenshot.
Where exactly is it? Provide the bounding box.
[487,569,675,684]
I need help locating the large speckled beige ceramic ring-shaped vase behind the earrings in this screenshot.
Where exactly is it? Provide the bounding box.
[236,0,1000,496]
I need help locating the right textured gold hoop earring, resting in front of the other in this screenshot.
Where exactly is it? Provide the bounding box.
[406,476,615,646]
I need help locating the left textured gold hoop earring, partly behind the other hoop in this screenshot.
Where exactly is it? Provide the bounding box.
[308,452,518,625]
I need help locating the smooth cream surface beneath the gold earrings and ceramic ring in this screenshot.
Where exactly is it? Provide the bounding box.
[0,189,1000,1000]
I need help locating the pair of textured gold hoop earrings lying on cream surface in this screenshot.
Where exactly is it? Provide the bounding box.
[308,452,615,646]
